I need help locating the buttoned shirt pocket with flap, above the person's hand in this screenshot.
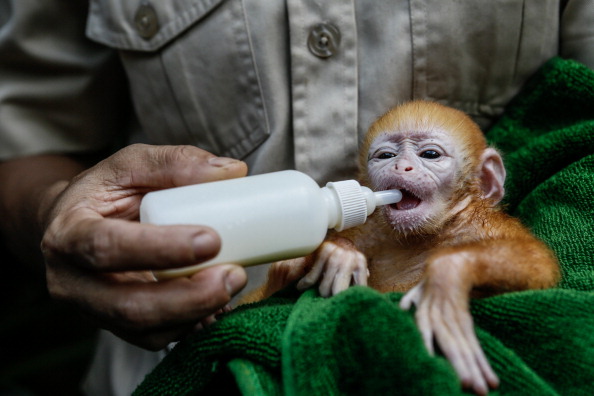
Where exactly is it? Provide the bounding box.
[87,0,269,158]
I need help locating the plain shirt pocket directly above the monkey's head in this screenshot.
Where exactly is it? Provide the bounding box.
[410,0,560,127]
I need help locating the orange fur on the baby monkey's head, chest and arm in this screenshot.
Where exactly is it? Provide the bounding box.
[252,101,560,304]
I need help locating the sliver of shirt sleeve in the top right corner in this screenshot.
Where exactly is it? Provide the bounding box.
[560,0,594,69]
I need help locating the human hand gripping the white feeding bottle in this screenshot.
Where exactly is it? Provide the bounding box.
[40,145,247,350]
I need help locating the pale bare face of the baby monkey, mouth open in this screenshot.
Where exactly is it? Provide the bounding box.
[367,130,461,234]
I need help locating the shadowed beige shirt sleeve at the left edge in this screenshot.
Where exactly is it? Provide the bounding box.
[0,0,130,160]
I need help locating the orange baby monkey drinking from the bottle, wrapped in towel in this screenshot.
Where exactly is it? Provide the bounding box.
[251,101,560,394]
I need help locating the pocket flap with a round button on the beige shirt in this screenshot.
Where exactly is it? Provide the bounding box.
[86,0,224,51]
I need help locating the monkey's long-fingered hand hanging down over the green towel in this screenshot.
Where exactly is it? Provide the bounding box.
[400,262,499,395]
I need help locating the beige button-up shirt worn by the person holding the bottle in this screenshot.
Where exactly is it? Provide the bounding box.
[0,0,594,182]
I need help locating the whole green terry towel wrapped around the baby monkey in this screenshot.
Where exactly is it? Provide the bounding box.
[135,59,594,395]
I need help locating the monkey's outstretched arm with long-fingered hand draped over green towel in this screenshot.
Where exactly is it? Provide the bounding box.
[400,233,559,394]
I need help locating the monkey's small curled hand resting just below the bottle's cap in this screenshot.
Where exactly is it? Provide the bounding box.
[297,238,369,297]
